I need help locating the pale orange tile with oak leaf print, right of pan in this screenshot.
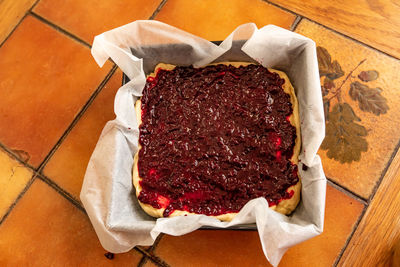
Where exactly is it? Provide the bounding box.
[296,20,400,198]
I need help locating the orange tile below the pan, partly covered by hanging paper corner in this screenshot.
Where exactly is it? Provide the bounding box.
[155,186,363,266]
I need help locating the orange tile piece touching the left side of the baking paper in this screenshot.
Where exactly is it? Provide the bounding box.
[43,70,122,199]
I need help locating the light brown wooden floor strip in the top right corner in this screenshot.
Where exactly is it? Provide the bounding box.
[270,0,400,58]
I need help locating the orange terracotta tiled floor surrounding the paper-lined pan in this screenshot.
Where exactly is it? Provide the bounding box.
[0,0,400,266]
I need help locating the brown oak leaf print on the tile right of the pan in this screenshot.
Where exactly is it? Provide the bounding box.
[317,46,389,163]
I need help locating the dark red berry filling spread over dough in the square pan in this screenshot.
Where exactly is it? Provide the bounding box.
[138,65,299,216]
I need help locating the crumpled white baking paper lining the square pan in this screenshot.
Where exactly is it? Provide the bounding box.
[80,21,326,266]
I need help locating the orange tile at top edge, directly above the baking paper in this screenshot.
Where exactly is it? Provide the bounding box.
[155,0,295,41]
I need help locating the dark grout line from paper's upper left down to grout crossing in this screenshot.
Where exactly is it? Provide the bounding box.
[37,65,118,173]
